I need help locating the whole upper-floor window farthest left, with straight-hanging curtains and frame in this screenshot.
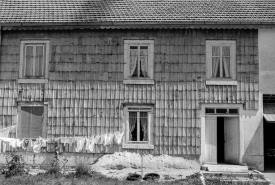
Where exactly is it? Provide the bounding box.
[18,40,50,83]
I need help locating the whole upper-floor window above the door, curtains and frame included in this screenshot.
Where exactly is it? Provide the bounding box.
[206,40,236,85]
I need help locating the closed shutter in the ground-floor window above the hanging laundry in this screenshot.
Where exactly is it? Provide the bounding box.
[19,106,44,138]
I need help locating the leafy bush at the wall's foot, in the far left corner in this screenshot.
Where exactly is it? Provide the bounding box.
[2,153,25,177]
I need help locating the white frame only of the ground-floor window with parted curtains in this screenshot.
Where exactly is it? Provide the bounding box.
[122,105,154,149]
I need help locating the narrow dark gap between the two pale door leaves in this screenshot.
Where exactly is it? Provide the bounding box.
[217,117,224,163]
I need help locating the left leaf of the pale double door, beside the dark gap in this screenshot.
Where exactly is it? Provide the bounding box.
[205,116,217,163]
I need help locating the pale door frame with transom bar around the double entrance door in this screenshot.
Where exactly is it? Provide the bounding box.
[200,103,244,164]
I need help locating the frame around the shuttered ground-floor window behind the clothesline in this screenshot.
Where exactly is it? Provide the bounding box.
[16,102,48,139]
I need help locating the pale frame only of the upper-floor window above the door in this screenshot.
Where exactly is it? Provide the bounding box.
[206,40,237,85]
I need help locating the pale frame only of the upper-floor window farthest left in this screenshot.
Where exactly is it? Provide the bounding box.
[18,40,50,83]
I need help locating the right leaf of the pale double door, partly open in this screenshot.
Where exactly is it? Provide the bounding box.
[224,117,239,164]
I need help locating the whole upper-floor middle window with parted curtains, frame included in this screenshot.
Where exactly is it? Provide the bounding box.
[123,40,154,84]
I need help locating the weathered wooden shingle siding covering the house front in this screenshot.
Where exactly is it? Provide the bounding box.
[0,29,259,155]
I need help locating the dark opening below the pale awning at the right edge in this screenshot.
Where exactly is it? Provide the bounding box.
[264,119,275,171]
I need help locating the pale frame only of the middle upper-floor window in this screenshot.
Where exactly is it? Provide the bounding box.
[123,40,154,84]
